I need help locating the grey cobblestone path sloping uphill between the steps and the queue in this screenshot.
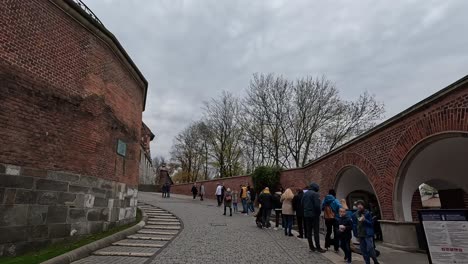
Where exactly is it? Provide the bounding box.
[139,192,331,264]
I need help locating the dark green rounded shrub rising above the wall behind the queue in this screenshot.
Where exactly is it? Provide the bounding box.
[252,166,281,193]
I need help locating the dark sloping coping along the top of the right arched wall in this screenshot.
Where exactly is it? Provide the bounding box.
[304,75,468,167]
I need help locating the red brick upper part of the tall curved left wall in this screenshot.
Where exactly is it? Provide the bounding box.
[0,0,144,186]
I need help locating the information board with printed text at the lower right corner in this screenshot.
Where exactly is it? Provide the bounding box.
[418,209,468,264]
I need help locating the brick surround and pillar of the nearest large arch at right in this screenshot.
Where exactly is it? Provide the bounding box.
[381,108,468,220]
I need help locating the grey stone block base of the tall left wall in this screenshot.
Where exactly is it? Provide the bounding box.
[0,164,138,256]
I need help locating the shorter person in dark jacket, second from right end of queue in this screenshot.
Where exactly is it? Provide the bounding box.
[336,208,353,263]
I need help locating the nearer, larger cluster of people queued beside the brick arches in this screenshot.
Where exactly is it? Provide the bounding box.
[256,183,379,264]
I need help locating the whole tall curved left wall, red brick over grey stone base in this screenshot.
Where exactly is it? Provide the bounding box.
[0,0,146,255]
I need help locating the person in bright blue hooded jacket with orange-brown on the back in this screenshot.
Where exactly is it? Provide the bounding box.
[322,189,341,252]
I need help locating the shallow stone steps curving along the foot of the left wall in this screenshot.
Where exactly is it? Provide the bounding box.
[73,203,181,264]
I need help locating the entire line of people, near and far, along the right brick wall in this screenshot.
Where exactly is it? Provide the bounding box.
[186,183,379,264]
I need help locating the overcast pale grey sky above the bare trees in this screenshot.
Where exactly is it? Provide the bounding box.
[85,0,468,158]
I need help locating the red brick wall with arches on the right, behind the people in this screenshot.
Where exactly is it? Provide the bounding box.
[171,78,468,220]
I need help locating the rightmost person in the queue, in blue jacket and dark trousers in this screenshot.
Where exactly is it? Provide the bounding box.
[352,200,379,264]
